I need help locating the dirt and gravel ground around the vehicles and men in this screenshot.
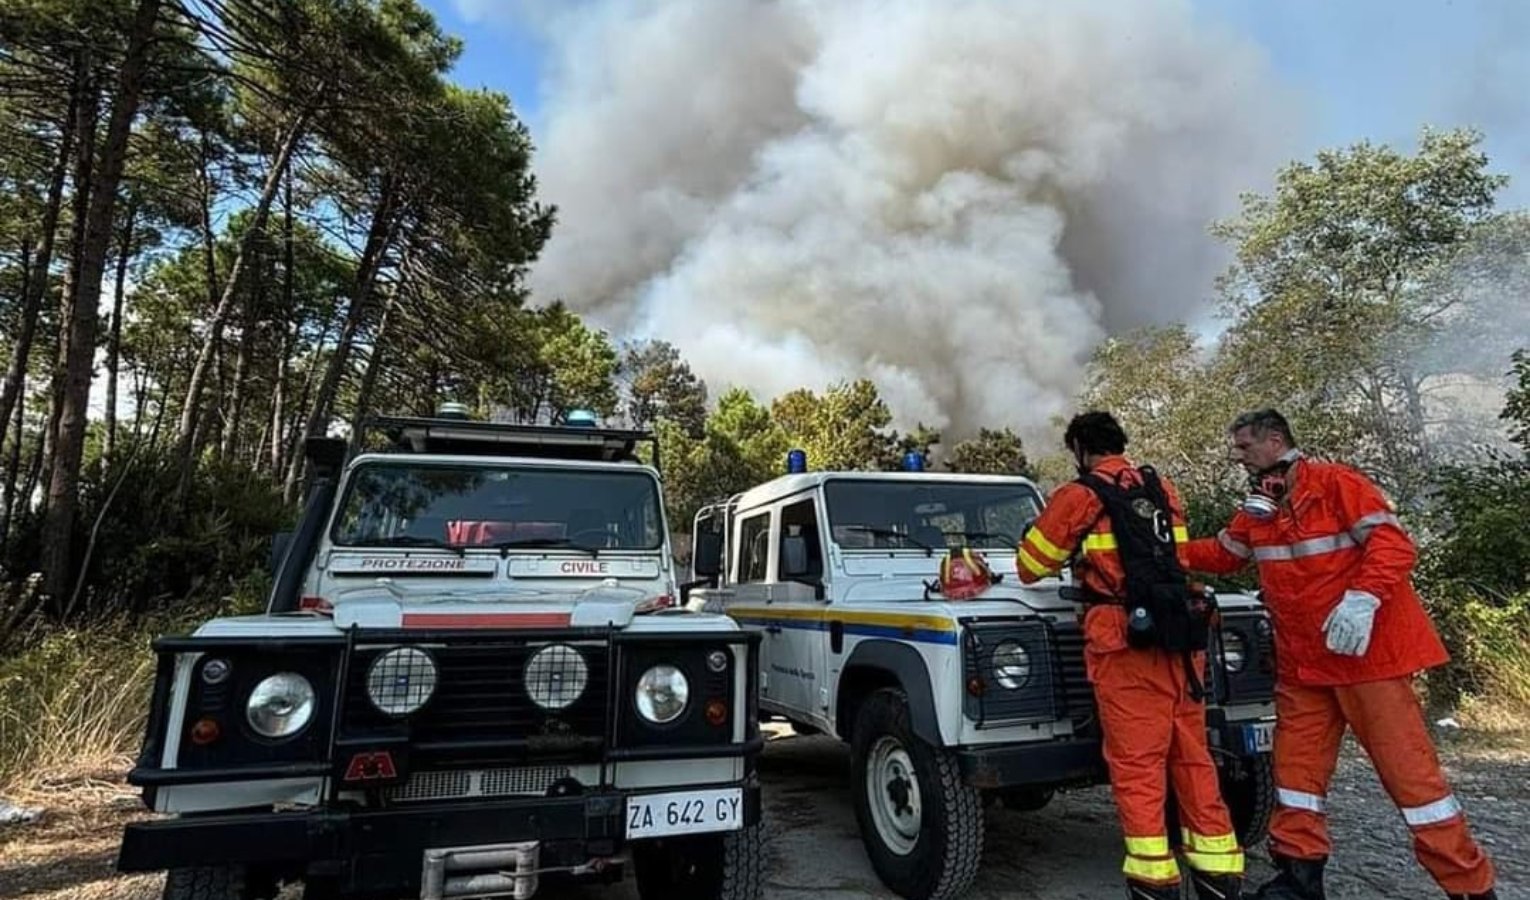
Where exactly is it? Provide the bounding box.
[0,732,1530,900]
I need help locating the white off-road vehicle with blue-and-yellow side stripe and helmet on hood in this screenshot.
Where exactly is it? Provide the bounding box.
[687,452,1274,900]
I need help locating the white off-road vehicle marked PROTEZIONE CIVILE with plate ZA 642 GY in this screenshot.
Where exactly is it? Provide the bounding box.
[118,415,762,900]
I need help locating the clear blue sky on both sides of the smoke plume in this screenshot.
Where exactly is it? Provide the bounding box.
[422,0,1530,207]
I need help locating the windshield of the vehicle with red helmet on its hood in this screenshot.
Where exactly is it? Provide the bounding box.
[823,479,1042,553]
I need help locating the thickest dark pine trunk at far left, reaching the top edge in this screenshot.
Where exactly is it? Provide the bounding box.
[43,0,159,602]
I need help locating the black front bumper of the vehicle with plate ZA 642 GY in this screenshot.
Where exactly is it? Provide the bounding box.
[118,781,760,895]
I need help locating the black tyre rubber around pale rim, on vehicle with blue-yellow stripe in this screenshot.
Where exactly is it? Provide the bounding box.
[851,689,984,900]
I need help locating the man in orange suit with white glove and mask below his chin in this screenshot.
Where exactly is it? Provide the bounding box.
[1186,410,1496,900]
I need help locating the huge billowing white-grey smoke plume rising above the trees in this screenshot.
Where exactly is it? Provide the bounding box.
[520,0,1294,438]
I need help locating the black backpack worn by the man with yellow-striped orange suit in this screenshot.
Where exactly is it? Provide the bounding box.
[1077,465,1210,658]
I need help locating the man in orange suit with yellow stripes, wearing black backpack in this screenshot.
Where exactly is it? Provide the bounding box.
[1017,412,1244,900]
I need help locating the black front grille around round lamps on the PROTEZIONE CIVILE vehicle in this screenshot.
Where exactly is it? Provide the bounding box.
[340,640,610,765]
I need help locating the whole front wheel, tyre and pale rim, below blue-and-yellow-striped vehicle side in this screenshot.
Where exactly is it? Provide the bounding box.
[851,689,984,900]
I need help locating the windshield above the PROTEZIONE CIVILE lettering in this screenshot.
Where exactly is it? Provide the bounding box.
[330,462,664,549]
